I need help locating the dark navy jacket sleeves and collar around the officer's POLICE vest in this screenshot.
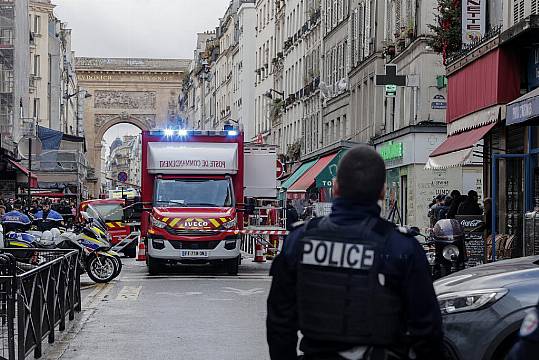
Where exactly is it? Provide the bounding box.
[266,199,442,360]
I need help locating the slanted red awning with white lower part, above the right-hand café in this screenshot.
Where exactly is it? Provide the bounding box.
[425,124,496,169]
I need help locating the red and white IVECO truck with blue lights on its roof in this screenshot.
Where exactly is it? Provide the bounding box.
[141,130,266,274]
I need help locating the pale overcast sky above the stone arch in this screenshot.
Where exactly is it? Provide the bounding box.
[52,0,229,59]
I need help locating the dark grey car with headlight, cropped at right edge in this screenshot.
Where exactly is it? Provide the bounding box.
[434,256,539,360]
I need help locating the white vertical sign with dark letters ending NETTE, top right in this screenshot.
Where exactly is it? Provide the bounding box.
[462,0,487,45]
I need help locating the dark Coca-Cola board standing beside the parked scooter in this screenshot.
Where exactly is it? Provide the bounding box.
[455,215,486,268]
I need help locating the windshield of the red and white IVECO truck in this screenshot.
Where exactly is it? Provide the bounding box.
[154,179,233,207]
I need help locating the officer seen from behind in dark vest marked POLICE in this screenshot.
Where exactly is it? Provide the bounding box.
[266,145,443,360]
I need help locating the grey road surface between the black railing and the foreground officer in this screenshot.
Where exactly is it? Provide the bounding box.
[47,258,271,360]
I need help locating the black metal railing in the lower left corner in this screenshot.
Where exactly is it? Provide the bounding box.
[0,249,81,360]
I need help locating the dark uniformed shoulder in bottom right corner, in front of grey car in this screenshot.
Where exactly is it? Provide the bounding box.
[508,304,539,360]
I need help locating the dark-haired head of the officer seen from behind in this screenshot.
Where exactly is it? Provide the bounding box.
[337,145,386,203]
